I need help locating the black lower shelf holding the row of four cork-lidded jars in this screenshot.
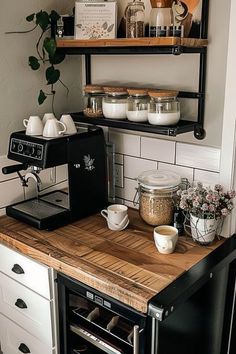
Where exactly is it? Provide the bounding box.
[70,112,201,136]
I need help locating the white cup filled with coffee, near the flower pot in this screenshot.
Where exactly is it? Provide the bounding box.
[154,225,178,254]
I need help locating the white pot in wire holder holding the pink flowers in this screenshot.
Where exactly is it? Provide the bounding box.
[190,214,219,245]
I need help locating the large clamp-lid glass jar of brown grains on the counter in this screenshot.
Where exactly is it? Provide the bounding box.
[137,170,181,226]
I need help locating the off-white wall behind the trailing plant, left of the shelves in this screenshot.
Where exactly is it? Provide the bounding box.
[0,0,81,155]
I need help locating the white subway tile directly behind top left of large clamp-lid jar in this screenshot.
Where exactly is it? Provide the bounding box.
[124,156,157,179]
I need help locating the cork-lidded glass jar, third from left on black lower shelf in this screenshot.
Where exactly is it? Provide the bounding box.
[126,89,149,122]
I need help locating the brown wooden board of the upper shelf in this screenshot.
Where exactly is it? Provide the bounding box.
[57,37,208,48]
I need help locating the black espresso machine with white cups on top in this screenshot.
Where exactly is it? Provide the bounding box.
[2,125,108,230]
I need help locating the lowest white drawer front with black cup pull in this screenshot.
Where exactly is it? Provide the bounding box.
[0,315,54,354]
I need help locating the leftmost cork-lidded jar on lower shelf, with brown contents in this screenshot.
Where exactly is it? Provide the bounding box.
[83,85,104,118]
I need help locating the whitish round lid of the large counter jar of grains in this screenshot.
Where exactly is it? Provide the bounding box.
[137,170,181,190]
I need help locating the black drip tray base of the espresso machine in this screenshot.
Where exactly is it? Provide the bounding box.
[6,191,70,230]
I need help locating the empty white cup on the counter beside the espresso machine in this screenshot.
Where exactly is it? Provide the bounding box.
[101,204,129,231]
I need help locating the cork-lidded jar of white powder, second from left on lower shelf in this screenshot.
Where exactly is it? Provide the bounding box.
[102,87,128,119]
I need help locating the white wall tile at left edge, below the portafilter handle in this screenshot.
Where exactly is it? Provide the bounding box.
[0,179,24,208]
